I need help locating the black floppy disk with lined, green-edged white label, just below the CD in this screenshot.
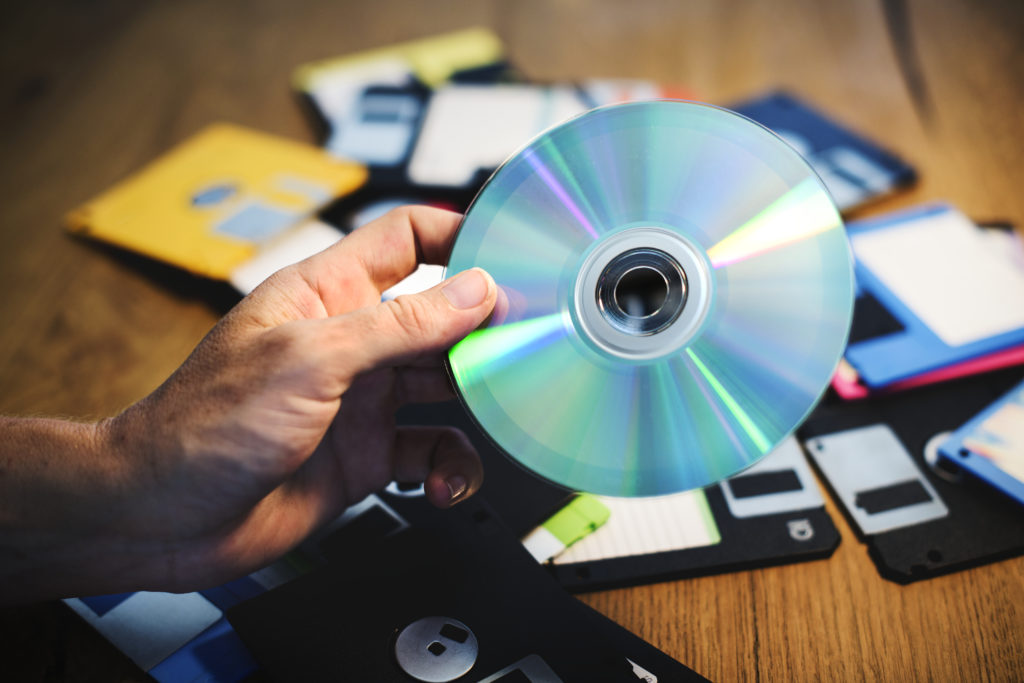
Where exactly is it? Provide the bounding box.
[398,401,840,592]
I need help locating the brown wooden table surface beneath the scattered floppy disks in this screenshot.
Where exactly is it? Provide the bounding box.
[0,0,1024,681]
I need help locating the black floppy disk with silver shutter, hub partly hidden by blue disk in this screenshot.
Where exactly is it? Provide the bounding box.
[798,368,1024,583]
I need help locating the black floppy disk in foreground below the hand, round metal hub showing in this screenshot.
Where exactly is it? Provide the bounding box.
[228,493,703,683]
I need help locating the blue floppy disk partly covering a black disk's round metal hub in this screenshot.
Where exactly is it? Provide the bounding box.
[939,383,1024,503]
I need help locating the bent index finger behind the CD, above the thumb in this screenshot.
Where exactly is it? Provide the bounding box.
[300,206,462,315]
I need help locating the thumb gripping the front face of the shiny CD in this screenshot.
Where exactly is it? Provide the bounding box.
[339,268,498,373]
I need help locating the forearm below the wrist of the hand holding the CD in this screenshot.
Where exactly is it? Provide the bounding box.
[0,418,161,603]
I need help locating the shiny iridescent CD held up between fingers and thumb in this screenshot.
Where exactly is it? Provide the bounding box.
[447,100,853,497]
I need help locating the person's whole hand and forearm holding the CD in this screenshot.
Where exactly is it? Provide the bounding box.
[0,207,497,602]
